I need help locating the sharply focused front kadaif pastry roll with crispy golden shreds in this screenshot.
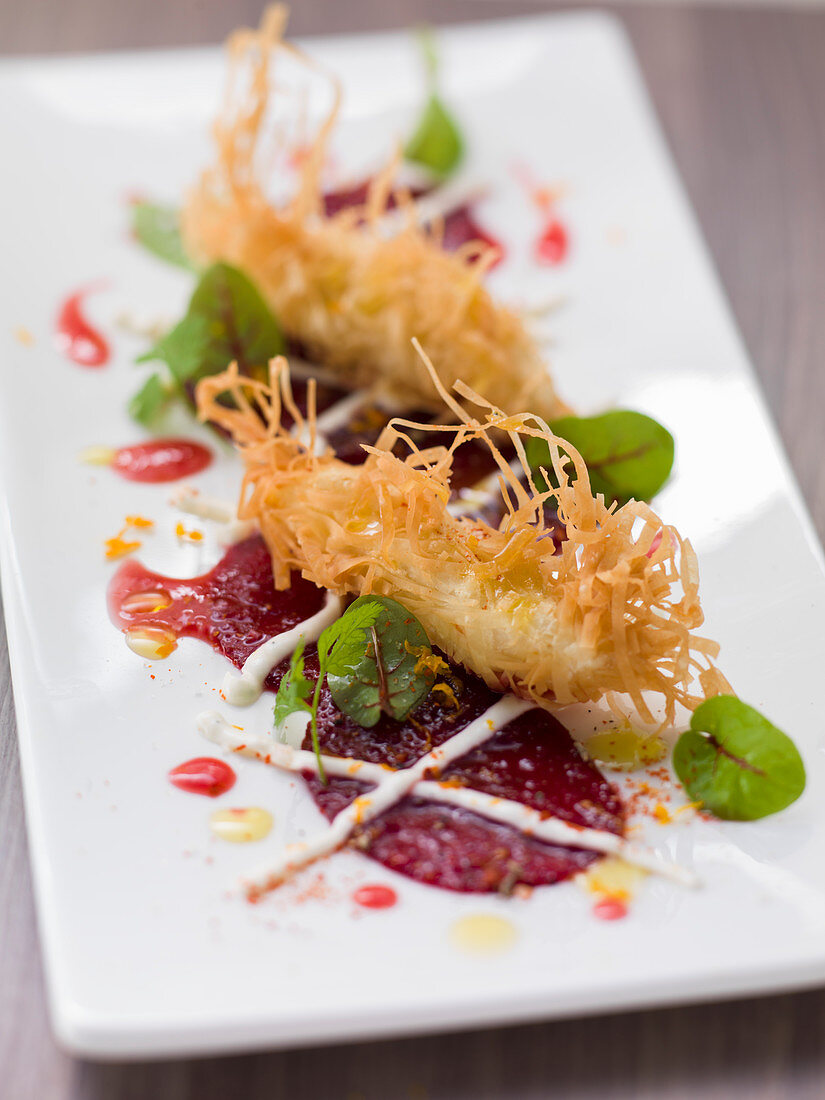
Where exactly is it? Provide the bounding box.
[197,355,725,724]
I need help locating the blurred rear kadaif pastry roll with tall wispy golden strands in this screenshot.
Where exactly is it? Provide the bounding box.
[182,7,567,419]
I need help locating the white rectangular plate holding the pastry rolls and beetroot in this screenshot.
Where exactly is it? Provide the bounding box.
[0,8,825,1056]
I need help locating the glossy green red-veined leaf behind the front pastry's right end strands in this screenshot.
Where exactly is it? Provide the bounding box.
[527,409,674,504]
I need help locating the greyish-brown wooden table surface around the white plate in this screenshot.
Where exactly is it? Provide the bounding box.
[0,0,825,1100]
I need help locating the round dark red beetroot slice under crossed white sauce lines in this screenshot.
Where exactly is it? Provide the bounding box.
[304,695,624,893]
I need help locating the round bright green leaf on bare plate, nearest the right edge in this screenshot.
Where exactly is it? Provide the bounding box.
[673,695,805,821]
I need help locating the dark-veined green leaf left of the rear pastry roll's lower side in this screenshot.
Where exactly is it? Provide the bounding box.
[129,263,284,424]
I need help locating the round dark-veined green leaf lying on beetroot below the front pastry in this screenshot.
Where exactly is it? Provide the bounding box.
[327,596,435,729]
